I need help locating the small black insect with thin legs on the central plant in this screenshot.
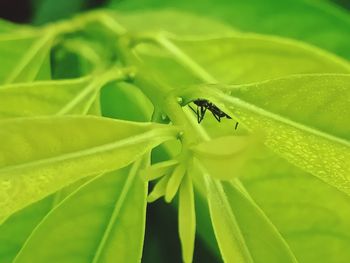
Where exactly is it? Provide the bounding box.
[189,99,238,130]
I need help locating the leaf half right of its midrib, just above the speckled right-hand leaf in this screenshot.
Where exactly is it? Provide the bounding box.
[170,34,350,84]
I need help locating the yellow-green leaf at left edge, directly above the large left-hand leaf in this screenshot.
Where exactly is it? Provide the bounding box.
[0,68,129,118]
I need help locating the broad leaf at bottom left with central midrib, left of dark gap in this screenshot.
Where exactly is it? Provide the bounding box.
[14,161,147,263]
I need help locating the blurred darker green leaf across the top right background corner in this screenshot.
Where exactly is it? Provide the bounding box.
[110,0,350,58]
